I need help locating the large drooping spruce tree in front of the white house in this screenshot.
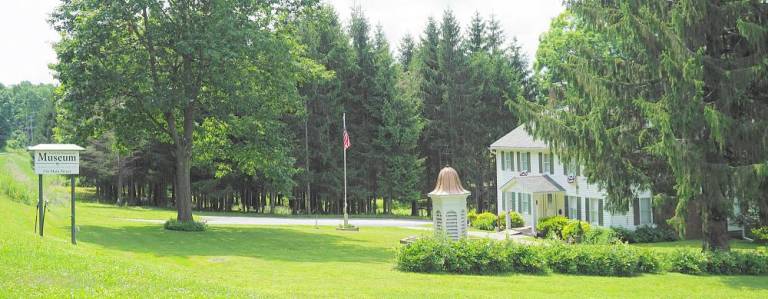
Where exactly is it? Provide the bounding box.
[515,0,768,250]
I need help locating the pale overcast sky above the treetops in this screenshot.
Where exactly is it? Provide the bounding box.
[0,0,563,85]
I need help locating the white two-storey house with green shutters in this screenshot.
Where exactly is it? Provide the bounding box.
[490,126,653,229]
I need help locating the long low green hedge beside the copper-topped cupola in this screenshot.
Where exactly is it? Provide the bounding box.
[396,237,768,276]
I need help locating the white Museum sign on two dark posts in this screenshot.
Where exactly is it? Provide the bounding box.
[28,144,84,244]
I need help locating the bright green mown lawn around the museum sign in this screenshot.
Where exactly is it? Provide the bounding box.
[0,154,768,298]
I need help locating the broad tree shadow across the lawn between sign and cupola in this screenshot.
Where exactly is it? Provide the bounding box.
[78,225,394,262]
